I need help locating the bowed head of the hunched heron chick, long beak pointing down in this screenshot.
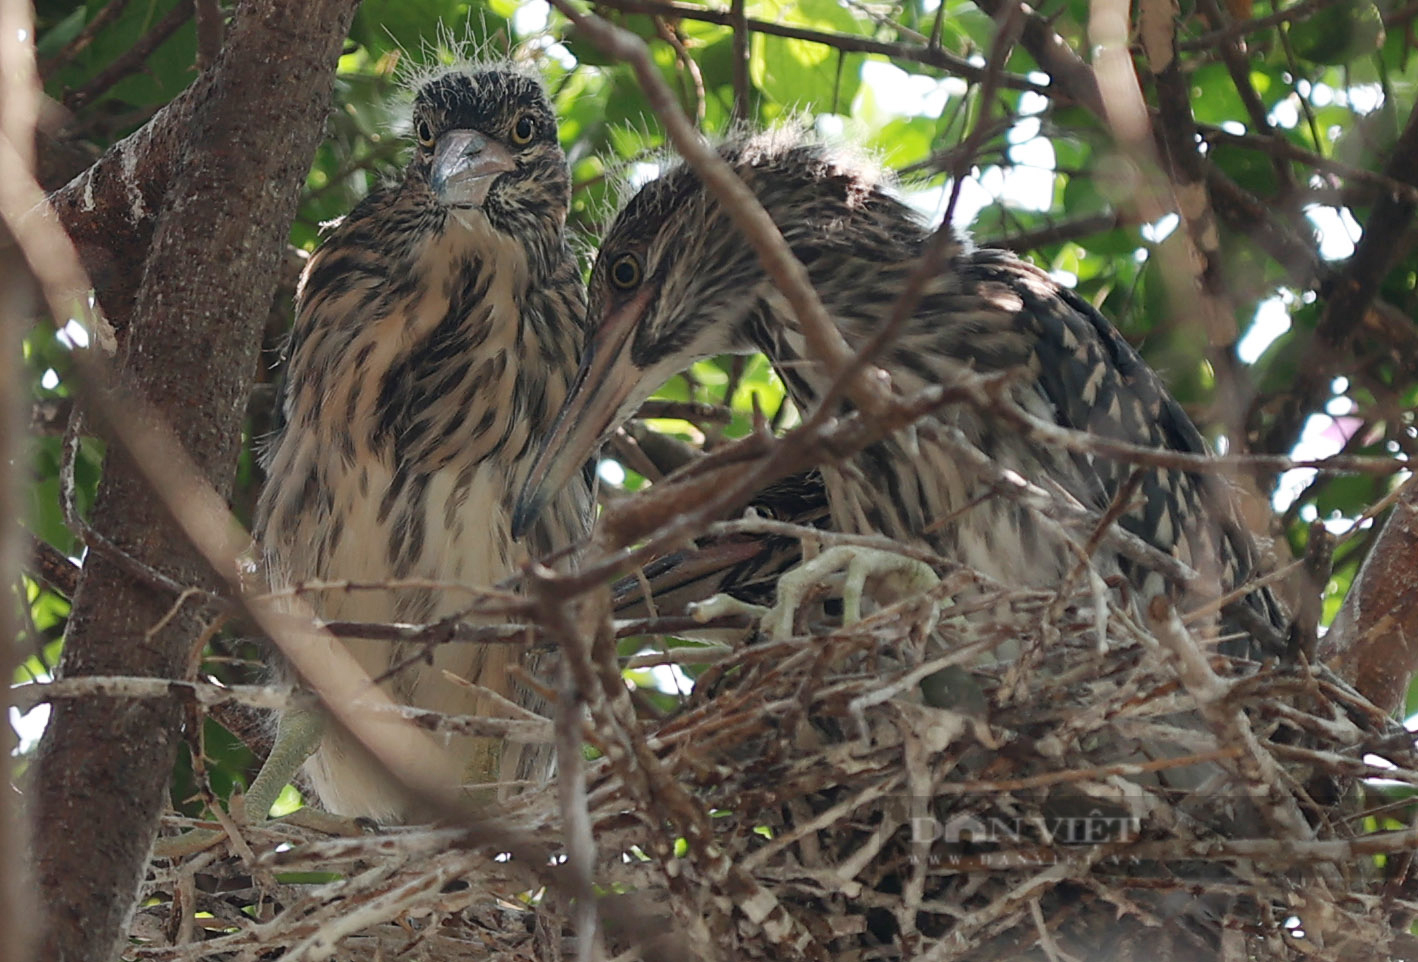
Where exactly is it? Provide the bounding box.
[513,132,895,531]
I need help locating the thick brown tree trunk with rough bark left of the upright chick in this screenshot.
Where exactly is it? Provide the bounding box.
[31,0,355,962]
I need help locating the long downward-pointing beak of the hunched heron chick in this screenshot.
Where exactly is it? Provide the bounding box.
[512,287,655,538]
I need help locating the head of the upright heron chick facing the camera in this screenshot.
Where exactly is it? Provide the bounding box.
[406,65,570,237]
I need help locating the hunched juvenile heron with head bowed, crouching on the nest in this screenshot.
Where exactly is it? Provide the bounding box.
[516,132,1280,654]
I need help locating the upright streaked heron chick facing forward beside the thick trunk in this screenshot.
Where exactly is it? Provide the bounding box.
[248,65,591,820]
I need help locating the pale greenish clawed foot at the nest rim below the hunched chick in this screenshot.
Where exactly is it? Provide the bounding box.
[763,545,940,640]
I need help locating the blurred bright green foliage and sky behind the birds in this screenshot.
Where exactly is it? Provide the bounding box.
[14,0,1418,810]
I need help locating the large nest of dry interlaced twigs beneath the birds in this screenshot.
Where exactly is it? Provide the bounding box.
[129,529,1418,962]
